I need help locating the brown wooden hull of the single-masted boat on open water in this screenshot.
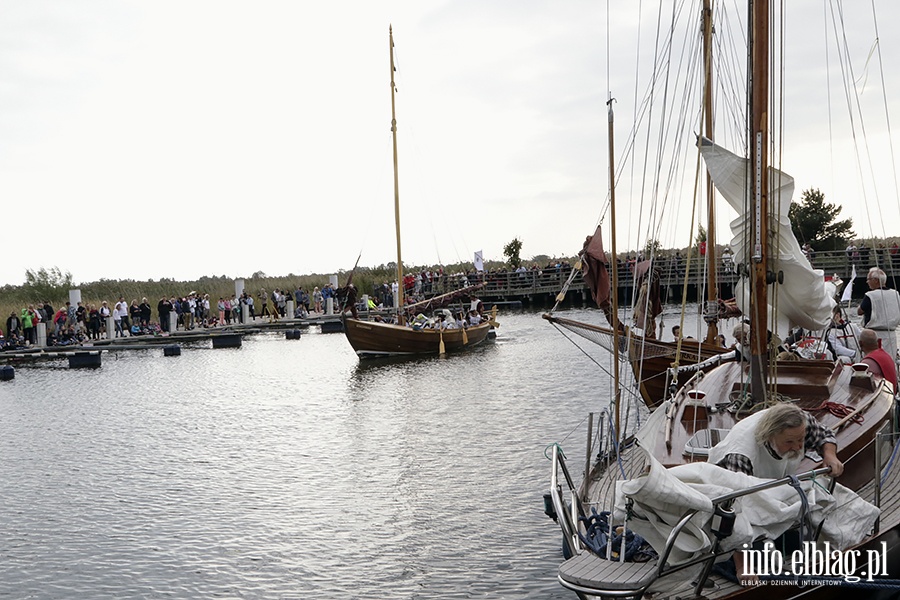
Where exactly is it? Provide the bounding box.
[344,319,491,358]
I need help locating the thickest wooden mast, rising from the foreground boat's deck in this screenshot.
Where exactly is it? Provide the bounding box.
[748,0,769,401]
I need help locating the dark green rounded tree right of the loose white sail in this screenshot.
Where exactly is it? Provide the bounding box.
[788,188,855,251]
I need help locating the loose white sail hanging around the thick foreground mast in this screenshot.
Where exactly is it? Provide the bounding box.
[700,138,834,335]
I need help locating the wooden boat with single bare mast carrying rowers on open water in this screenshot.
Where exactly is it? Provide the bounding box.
[344,28,498,358]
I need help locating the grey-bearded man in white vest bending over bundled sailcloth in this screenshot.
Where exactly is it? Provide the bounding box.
[709,402,844,583]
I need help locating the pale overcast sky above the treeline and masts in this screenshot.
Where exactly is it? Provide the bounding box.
[0,0,900,285]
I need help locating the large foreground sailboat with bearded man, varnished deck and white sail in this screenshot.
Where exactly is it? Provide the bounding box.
[545,0,900,600]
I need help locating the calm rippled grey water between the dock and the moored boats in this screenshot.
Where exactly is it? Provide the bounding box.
[0,311,632,599]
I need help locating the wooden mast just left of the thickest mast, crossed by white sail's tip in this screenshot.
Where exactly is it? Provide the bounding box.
[702,0,719,345]
